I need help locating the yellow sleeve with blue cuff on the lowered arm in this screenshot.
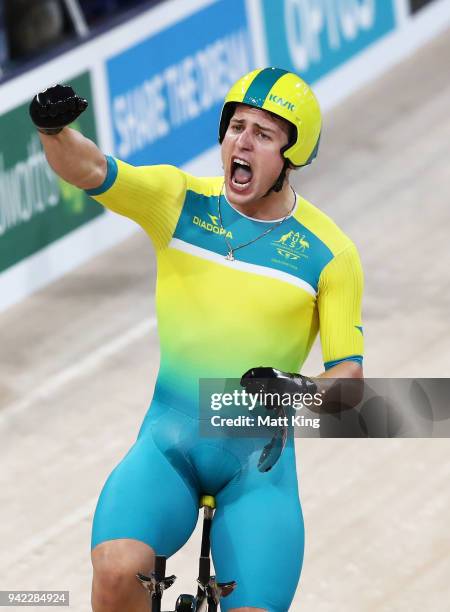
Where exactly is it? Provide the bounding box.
[318,244,364,370]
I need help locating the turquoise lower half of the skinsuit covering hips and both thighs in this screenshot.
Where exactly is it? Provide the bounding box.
[92,399,304,612]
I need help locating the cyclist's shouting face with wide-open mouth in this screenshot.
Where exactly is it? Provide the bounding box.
[222,104,289,205]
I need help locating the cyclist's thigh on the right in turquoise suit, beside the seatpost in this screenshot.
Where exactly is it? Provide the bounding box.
[211,444,304,612]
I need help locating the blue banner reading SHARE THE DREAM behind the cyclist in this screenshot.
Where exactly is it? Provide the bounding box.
[107,0,253,165]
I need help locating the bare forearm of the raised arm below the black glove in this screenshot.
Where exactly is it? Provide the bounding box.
[39,127,106,189]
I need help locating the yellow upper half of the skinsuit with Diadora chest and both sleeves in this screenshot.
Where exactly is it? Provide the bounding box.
[88,158,363,404]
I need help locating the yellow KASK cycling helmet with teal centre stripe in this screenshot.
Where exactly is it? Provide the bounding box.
[219,67,322,166]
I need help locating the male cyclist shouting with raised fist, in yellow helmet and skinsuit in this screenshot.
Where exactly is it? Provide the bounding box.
[30,68,362,612]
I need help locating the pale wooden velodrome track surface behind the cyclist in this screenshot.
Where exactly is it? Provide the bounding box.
[0,31,450,612]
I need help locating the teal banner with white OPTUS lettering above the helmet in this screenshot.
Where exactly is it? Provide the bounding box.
[261,0,395,83]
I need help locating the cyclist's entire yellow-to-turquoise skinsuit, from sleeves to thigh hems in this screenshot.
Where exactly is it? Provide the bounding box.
[89,158,363,612]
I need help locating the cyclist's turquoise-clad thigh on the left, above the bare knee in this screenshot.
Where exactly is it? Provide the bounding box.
[92,418,198,556]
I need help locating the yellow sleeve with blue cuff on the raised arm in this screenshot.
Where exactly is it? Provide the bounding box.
[87,156,186,250]
